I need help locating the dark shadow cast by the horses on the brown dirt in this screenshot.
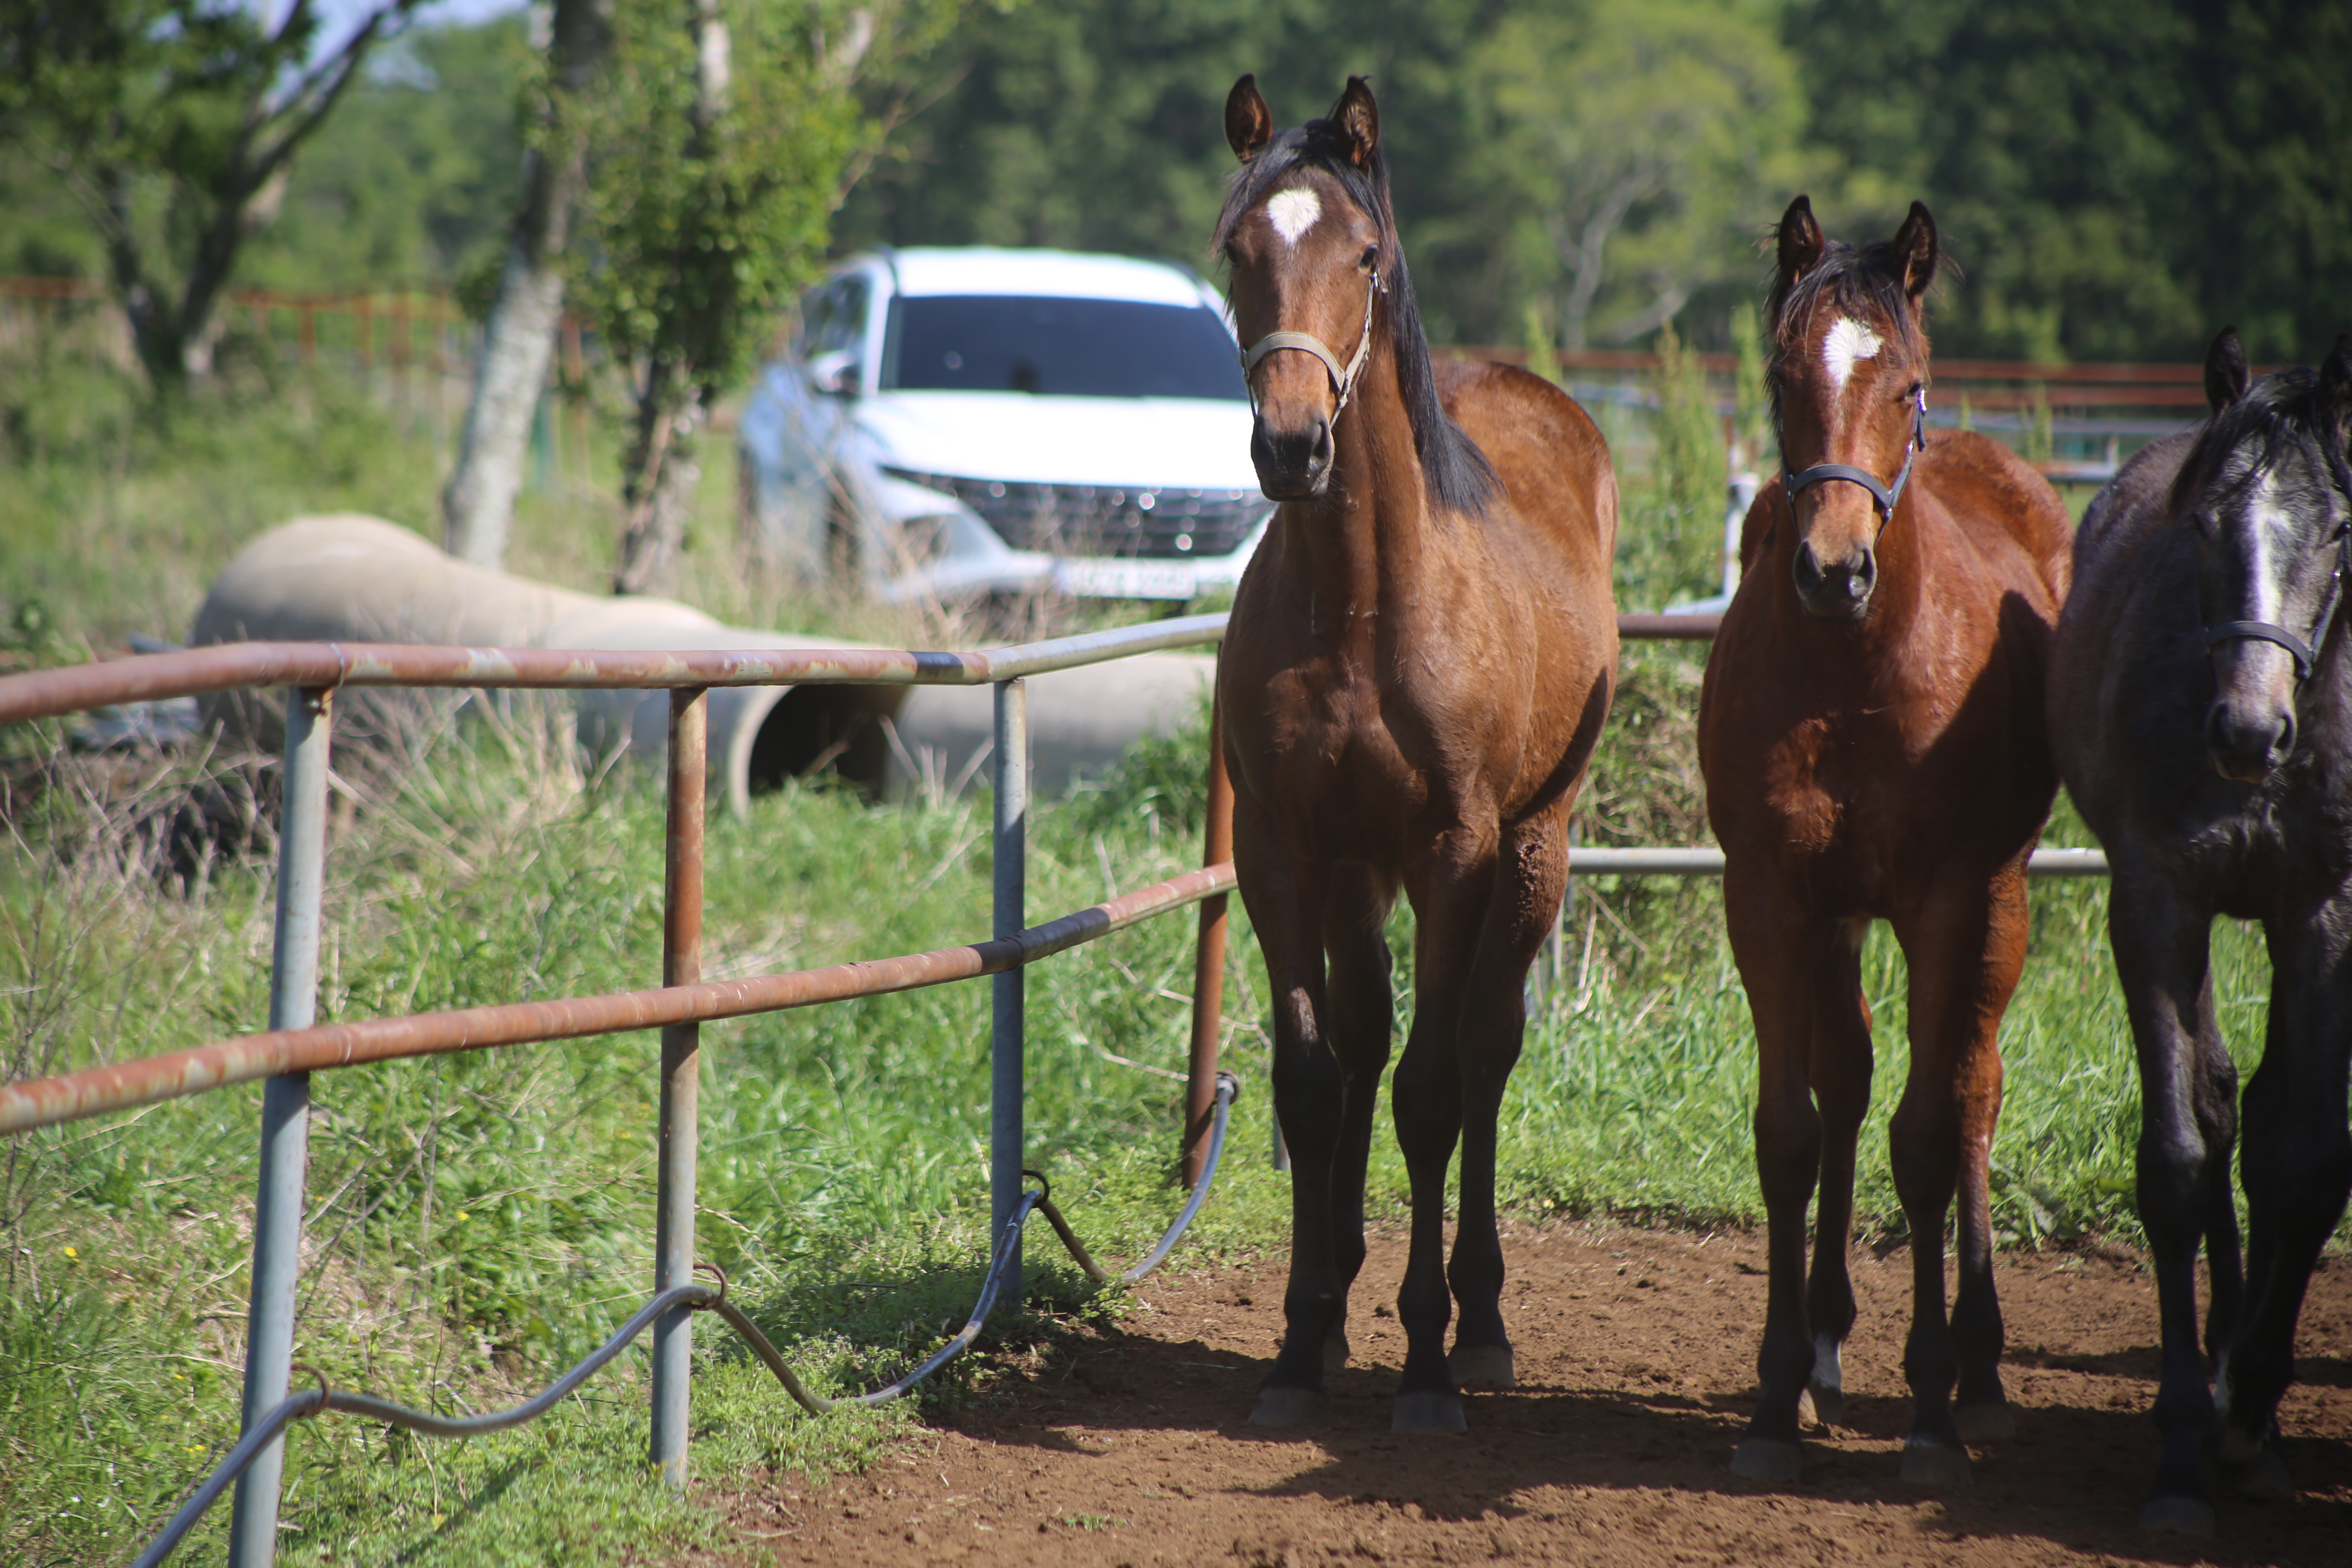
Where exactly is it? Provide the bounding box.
[953,1328,2352,1566]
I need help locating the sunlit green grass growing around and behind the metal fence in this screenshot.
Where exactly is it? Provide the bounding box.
[0,355,2314,1563]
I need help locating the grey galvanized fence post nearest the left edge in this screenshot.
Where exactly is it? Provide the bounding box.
[228,686,334,1568]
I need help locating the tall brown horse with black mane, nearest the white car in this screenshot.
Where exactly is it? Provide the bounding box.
[1216,75,1616,1432]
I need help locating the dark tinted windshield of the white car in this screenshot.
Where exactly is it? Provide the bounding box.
[882,294,1249,402]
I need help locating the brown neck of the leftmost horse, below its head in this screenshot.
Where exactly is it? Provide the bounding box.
[1296,341,1430,635]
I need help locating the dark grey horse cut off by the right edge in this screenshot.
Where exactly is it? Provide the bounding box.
[2049,327,2352,1535]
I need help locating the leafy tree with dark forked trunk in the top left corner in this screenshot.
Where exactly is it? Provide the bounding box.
[0,0,419,388]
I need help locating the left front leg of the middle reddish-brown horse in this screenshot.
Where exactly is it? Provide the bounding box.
[1724,856,1842,1483]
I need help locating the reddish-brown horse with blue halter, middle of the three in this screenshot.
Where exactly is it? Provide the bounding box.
[1698,195,2067,1483]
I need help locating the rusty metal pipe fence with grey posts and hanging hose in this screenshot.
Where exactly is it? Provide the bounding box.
[0,616,2105,1568]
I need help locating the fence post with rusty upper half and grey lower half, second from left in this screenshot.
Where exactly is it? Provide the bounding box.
[652,686,710,1486]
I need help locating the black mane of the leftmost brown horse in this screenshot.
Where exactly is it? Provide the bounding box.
[1209,120,1496,517]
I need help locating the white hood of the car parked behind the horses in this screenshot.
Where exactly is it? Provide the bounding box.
[856,392,1258,489]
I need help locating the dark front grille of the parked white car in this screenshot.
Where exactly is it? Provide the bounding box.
[887,468,1275,559]
